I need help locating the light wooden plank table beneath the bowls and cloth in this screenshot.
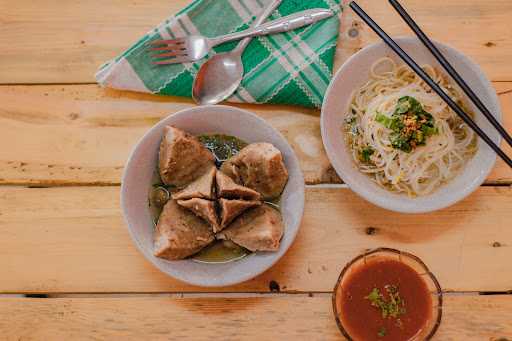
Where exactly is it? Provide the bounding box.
[0,0,512,340]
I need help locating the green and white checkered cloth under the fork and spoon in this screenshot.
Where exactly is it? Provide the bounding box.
[96,0,341,108]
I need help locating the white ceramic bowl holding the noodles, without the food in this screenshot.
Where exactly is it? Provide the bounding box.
[321,37,501,213]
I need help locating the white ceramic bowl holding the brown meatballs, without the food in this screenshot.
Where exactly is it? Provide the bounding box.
[121,105,304,287]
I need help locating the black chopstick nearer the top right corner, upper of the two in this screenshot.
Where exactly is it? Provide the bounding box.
[389,0,512,146]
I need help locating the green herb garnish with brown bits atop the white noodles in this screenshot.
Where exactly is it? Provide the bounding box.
[375,96,439,153]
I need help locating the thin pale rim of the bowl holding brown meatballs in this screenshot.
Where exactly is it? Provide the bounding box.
[120,105,305,288]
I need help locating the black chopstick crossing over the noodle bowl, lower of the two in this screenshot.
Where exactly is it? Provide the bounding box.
[350,1,512,168]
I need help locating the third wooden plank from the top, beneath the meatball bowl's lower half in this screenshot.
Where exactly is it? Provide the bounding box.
[0,186,512,293]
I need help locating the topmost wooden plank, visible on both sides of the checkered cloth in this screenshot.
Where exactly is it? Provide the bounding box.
[0,0,512,84]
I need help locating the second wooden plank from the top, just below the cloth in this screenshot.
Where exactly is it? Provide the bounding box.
[0,82,512,186]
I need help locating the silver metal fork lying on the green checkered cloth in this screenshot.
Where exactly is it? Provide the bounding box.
[149,8,334,65]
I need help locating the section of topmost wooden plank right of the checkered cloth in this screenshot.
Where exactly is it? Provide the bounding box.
[336,0,512,81]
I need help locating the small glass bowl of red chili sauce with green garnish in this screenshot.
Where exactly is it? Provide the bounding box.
[332,248,443,341]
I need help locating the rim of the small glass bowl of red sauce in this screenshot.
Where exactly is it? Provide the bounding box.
[331,247,443,340]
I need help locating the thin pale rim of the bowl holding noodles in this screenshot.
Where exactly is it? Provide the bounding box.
[320,36,503,214]
